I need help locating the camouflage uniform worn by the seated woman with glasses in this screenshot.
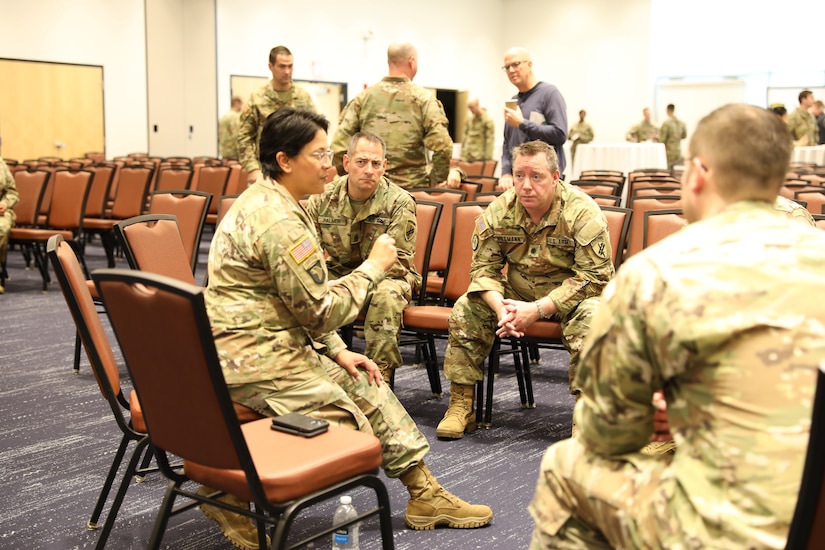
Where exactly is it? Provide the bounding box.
[205,178,429,477]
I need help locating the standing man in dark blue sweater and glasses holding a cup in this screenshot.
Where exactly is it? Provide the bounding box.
[498,47,567,194]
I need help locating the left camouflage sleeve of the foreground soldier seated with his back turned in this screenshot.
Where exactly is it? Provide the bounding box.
[574,264,678,455]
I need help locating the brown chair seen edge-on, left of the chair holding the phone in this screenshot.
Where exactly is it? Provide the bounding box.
[46,235,150,548]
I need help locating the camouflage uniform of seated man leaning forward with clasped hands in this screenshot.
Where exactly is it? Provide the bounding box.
[444,181,614,392]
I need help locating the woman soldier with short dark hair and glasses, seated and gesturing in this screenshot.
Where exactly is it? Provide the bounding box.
[205,107,493,547]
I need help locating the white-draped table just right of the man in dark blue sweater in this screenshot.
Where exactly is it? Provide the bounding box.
[569,143,667,180]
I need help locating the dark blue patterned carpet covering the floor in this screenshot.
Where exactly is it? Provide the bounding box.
[0,235,573,550]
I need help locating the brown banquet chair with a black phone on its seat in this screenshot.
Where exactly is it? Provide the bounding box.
[92,269,393,549]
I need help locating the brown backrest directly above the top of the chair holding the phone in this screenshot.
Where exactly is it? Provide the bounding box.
[114,214,195,284]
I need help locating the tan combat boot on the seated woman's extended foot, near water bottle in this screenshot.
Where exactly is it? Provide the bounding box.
[401,462,493,531]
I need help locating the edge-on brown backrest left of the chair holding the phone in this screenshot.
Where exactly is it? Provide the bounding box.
[46,235,128,419]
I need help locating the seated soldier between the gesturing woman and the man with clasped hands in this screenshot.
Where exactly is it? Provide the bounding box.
[306,132,421,382]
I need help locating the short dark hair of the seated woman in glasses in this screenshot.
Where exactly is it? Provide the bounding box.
[260,107,329,179]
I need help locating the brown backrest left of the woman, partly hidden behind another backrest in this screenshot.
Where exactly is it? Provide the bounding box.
[149,191,212,273]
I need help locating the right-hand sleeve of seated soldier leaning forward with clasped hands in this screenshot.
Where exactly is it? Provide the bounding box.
[549,207,614,314]
